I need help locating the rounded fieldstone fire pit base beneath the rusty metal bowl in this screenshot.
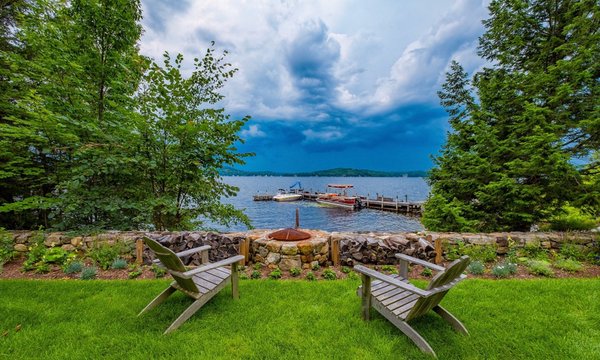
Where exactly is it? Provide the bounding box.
[250,229,329,271]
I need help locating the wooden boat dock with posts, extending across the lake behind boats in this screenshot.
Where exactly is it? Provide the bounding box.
[253,191,423,216]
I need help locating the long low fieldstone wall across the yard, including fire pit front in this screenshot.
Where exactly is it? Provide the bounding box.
[10,230,600,270]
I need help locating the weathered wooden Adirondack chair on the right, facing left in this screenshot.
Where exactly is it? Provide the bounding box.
[354,254,470,356]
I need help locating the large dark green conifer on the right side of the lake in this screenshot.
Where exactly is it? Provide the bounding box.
[424,0,600,231]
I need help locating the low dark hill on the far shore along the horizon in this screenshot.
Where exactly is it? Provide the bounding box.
[219,167,427,177]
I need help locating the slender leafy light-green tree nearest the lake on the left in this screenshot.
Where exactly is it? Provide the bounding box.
[139,48,249,230]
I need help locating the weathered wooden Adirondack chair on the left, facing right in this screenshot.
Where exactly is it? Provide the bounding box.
[138,237,244,334]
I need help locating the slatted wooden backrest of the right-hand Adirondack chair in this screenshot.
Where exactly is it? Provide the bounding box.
[405,256,471,321]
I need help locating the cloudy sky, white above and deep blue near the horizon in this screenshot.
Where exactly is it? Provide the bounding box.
[140,0,489,172]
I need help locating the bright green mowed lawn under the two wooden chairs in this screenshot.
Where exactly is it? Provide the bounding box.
[0,279,600,359]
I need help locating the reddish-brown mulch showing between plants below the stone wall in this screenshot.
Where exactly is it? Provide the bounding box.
[0,259,600,280]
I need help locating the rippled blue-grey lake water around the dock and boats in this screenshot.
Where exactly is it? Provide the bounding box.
[212,176,429,231]
